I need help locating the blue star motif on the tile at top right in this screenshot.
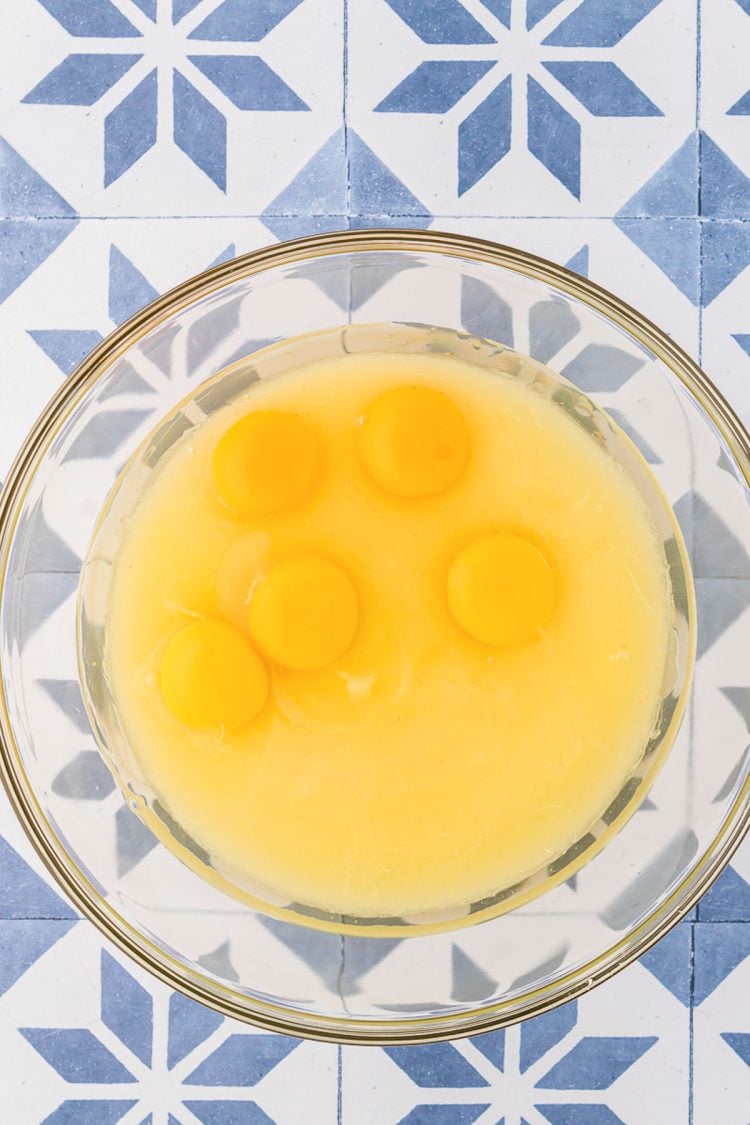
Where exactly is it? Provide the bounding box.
[374,0,662,199]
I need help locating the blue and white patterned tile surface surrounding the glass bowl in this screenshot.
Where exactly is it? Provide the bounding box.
[0,0,750,1125]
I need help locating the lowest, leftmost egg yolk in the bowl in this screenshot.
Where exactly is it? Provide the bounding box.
[159,619,269,729]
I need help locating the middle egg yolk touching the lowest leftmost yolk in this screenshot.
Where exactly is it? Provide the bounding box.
[249,555,360,672]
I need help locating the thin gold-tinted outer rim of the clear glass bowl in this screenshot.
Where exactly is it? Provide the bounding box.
[0,228,750,1044]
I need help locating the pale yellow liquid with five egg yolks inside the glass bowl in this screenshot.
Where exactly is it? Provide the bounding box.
[107,354,672,917]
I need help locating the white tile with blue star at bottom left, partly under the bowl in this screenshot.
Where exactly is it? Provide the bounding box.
[0,921,337,1125]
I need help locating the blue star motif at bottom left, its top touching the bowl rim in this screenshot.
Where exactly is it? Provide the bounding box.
[19,950,299,1125]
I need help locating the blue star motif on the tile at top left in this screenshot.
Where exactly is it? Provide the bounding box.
[22,0,309,191]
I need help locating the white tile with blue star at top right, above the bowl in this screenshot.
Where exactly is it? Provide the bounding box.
[347,0,696,216]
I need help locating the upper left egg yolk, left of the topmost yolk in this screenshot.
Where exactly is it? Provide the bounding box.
[211,411,322,516]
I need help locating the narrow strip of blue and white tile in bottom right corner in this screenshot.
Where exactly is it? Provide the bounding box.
[693,923,750,1125]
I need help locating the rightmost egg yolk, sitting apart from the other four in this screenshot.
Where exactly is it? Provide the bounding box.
[448,532,558,647]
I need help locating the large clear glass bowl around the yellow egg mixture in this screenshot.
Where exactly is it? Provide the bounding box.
[0,230,750,1043]
